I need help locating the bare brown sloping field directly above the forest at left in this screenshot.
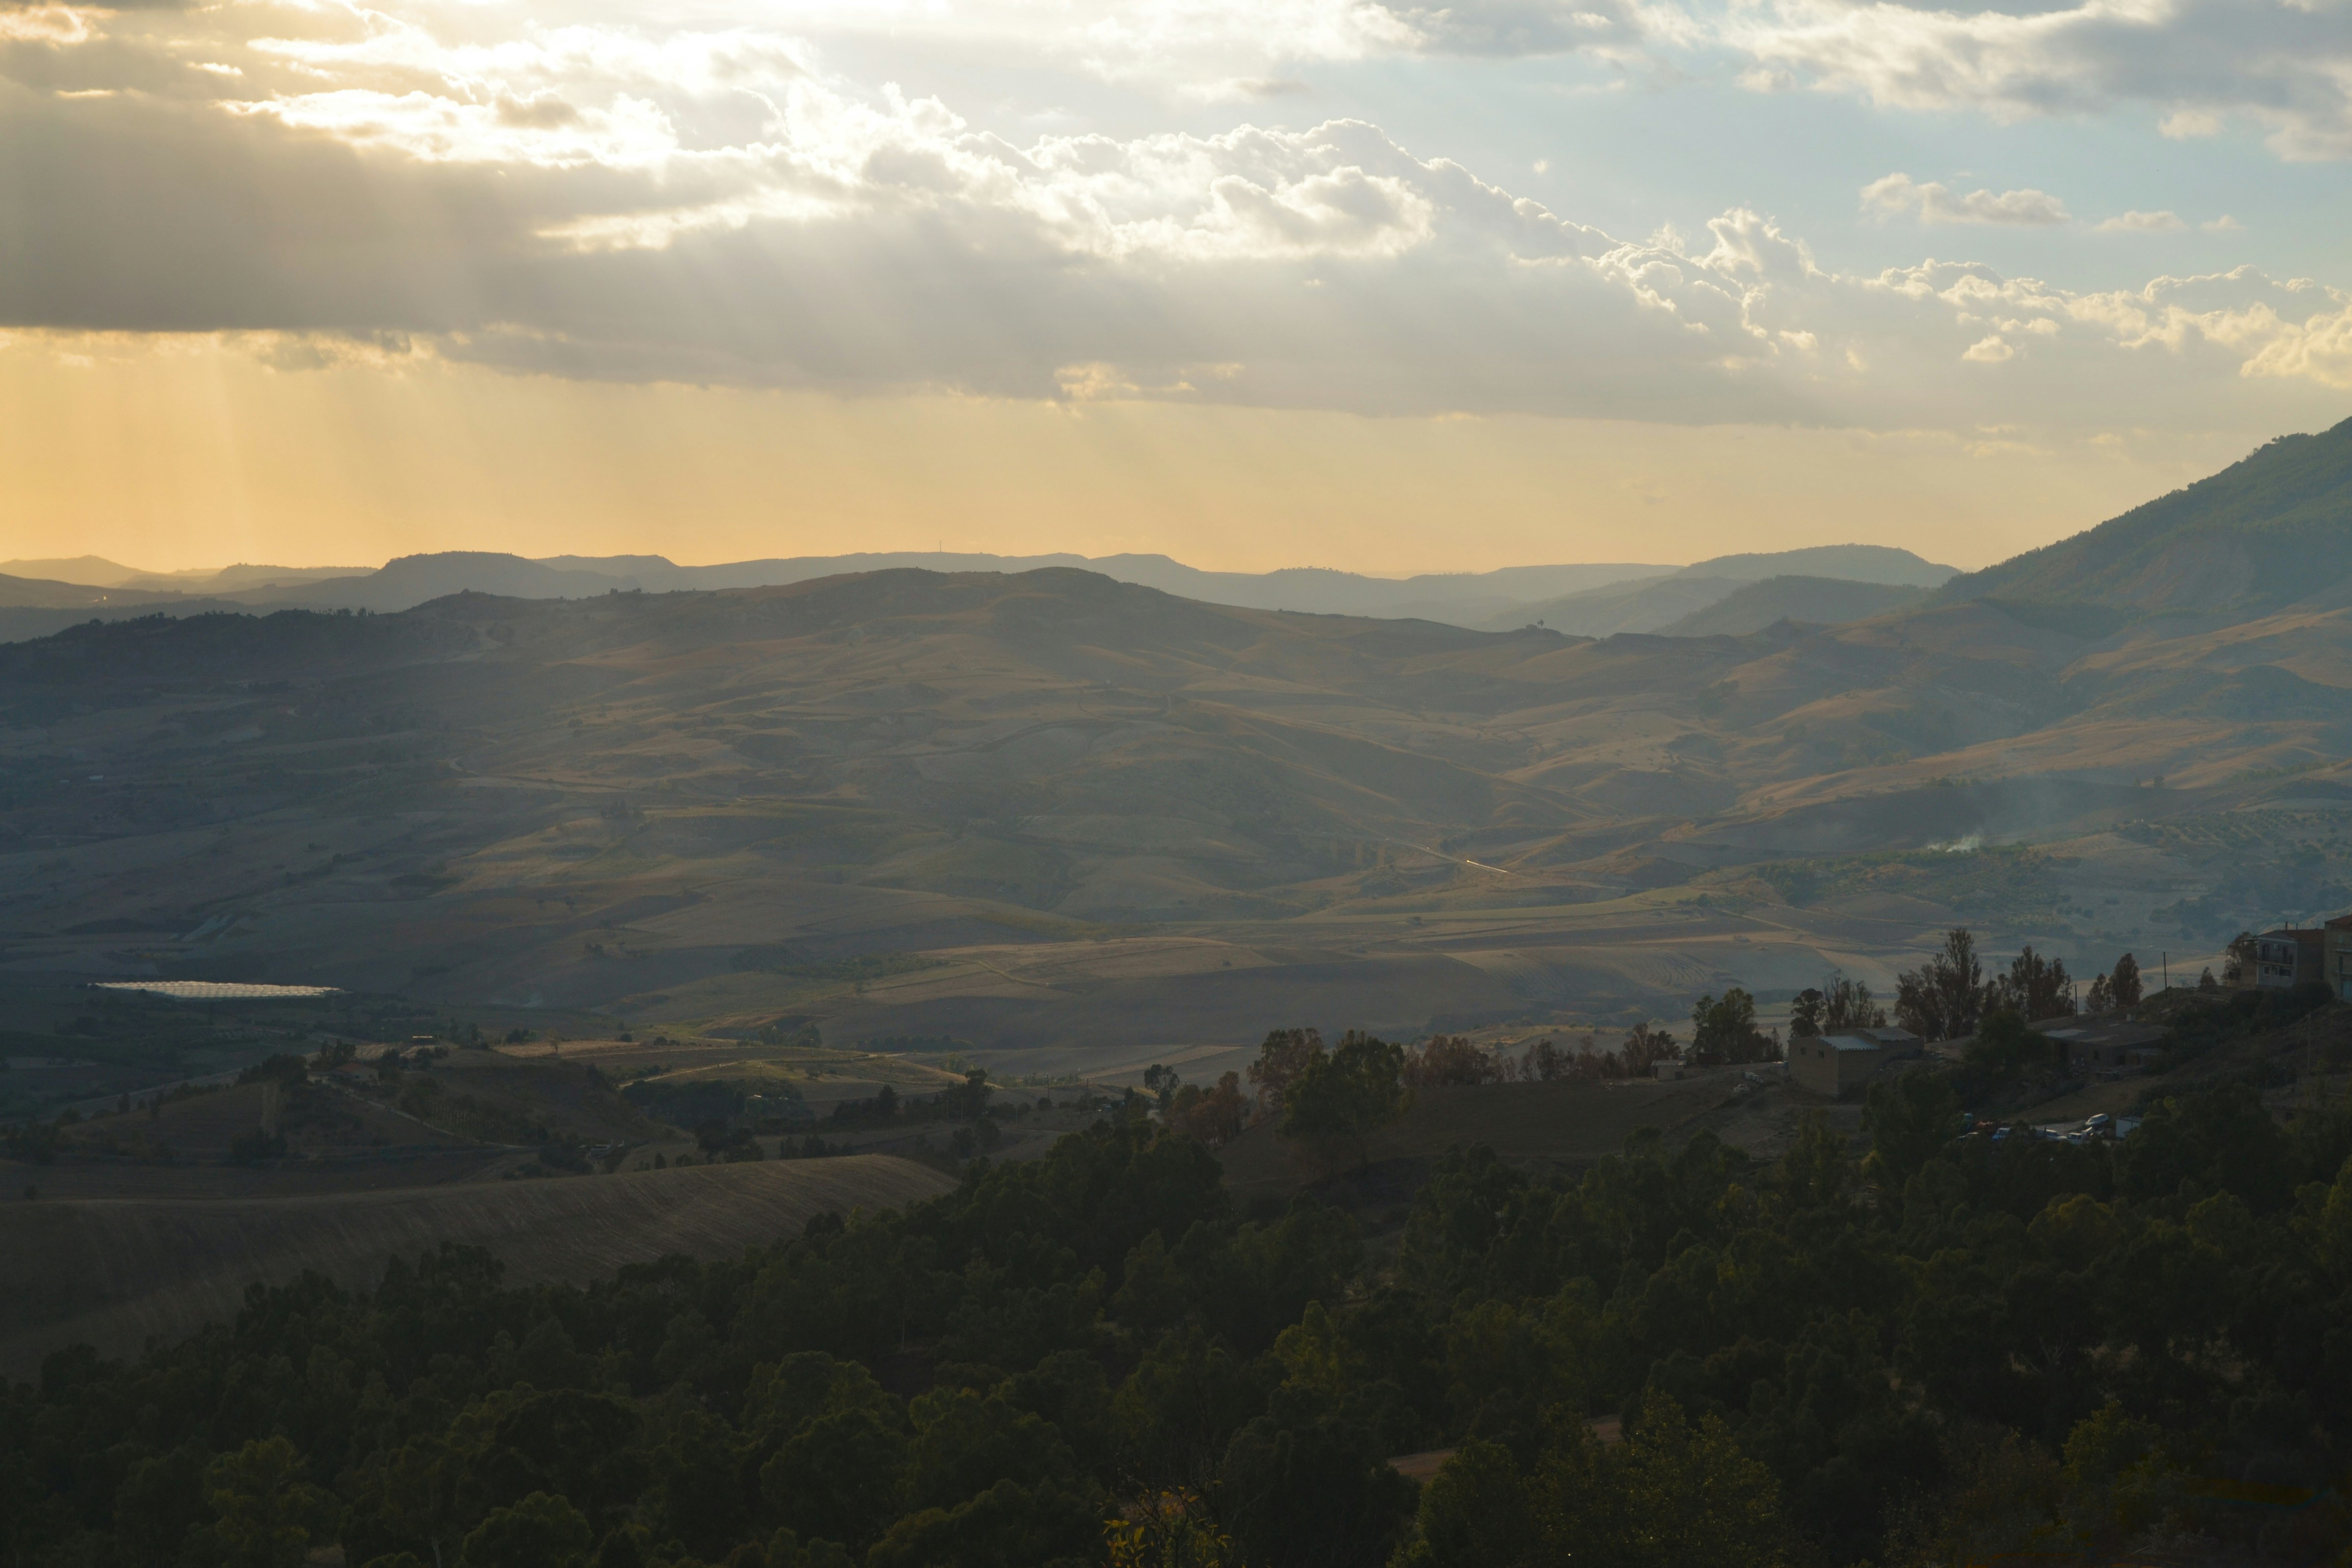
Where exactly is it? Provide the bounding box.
[0,1154,952,1378]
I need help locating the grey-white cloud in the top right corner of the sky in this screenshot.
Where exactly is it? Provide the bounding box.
[1714,0,2352,160]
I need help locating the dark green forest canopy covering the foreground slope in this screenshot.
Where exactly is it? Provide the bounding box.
[0,1067,2352,1568]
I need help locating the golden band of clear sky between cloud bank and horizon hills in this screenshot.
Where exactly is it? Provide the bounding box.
[0,336,2276,574]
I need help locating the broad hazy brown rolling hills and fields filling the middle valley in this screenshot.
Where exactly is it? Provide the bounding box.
[0,550,2352,1053]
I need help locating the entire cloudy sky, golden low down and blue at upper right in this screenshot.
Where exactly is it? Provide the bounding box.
[0,0,2352,574]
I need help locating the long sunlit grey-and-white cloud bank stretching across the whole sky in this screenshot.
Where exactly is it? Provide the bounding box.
[0,0,2352,428]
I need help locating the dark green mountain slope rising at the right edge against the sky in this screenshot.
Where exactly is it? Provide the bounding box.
[1938,421,2352,614]
